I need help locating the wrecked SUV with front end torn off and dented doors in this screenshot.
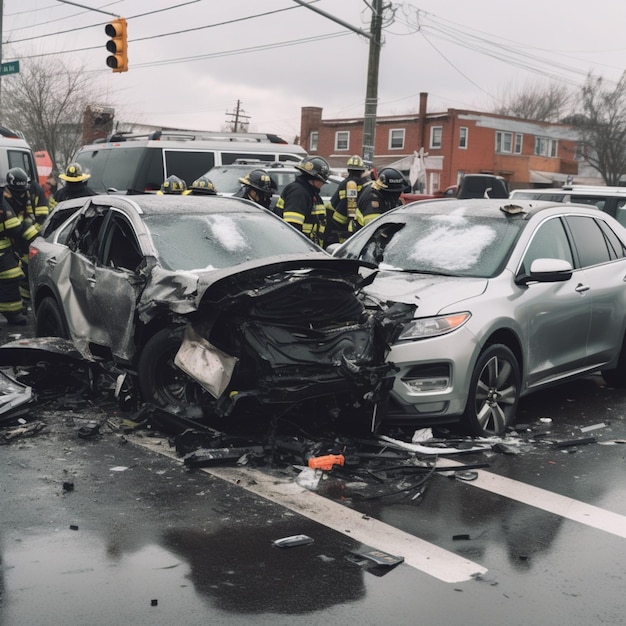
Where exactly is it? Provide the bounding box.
[29,195,404,426]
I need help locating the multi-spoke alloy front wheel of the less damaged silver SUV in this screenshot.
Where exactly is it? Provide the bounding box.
[463,344,521,437]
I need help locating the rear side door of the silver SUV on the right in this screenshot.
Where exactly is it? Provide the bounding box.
[565,215,626,367]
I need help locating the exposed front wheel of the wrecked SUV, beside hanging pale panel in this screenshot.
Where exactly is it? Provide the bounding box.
[137,328,202,411]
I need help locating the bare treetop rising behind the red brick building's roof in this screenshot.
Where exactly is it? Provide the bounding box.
[493,82,572,122]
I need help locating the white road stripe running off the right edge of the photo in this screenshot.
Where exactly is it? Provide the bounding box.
[437,459,626,539]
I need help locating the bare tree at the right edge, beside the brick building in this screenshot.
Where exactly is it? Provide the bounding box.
[564,72,626,185]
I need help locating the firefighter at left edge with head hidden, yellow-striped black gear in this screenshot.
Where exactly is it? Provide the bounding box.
[0,190,38,326]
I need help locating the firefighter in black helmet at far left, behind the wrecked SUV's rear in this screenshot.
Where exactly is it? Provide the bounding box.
[2,167,48,300]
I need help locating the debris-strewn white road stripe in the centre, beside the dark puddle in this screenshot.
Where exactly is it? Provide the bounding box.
[203,467,487,583]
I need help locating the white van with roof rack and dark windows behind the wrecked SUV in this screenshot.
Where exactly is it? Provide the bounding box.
[74,131,307,194]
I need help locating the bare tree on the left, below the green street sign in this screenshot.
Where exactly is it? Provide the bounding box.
[1,57,101,171]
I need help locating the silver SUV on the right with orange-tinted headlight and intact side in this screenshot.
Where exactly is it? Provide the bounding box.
[334,199,626,436]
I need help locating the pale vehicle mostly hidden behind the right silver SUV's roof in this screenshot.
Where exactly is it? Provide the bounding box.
[511,185,626,226]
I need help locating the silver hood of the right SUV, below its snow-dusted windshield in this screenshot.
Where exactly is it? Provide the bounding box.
[364,270,488,316]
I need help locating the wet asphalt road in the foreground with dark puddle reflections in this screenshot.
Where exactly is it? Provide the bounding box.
[0,316,626,626]
